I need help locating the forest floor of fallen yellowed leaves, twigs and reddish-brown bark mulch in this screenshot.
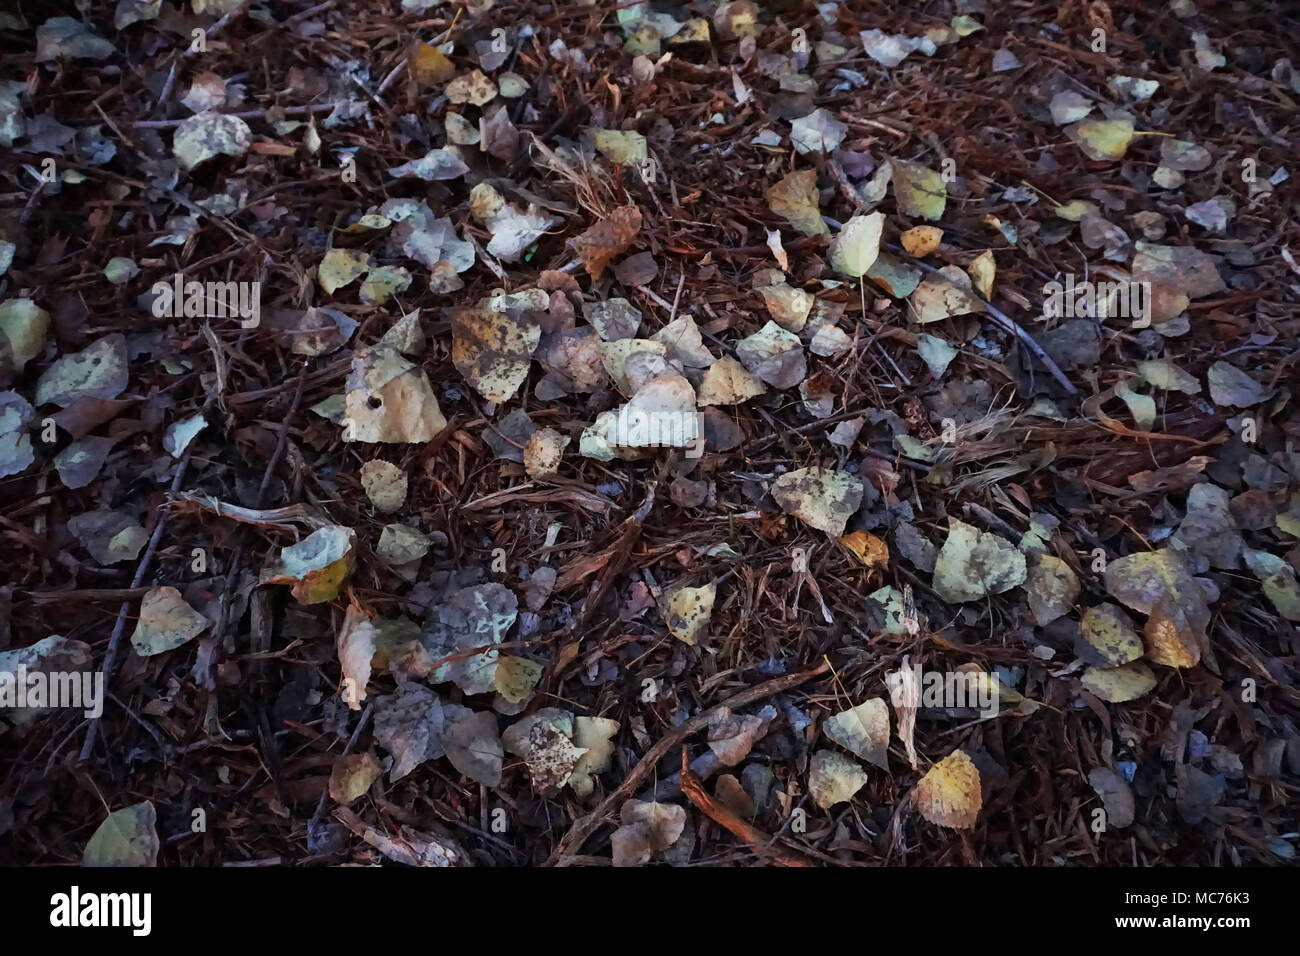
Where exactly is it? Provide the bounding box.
[0,0,1300,866]
